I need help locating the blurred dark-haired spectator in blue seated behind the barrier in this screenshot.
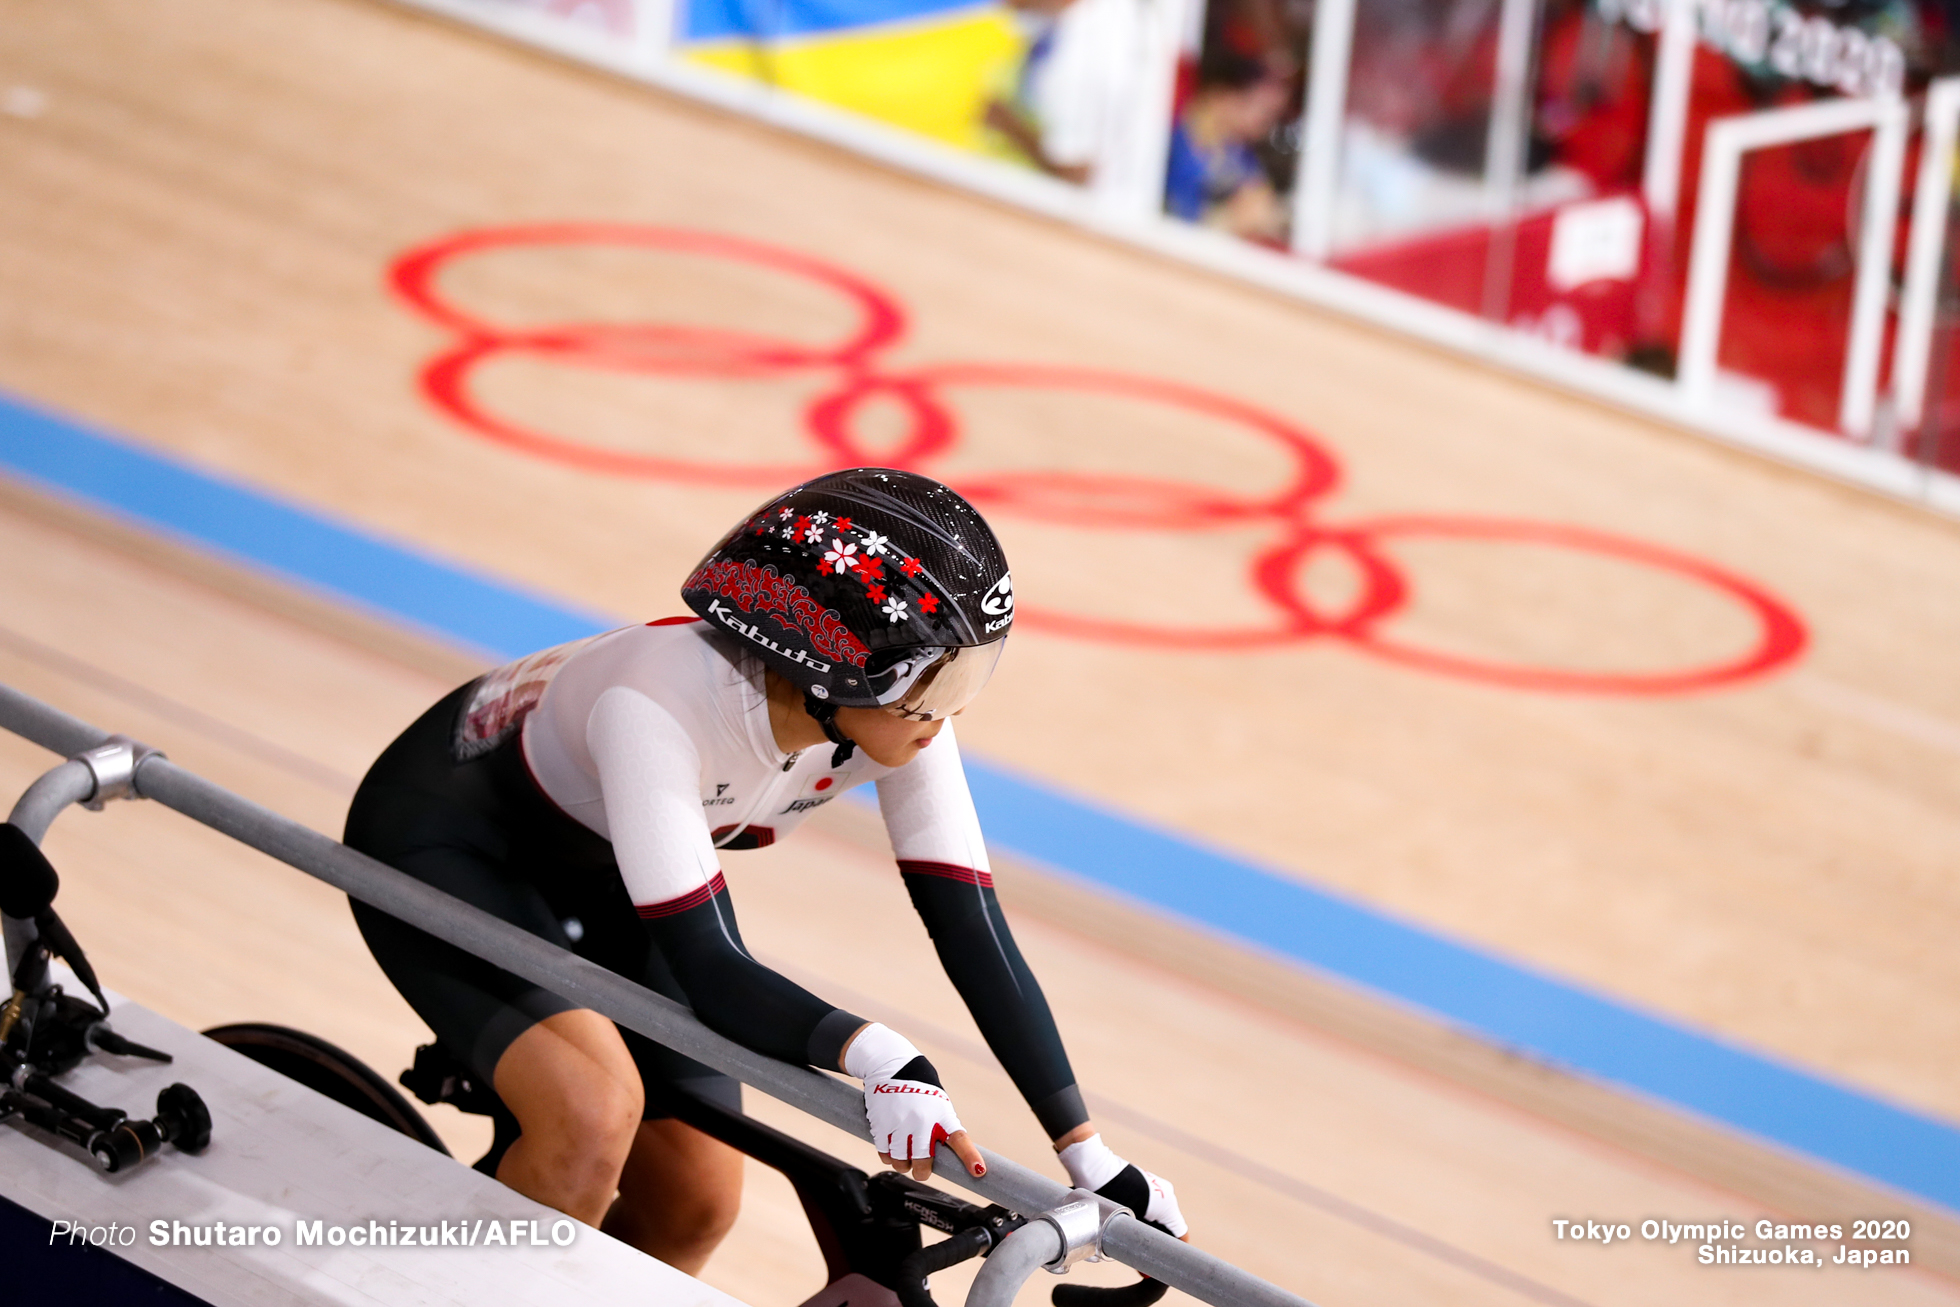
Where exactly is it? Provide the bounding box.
[1164,51,1292,241]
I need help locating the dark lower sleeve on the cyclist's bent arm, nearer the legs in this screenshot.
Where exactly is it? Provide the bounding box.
[647,876,864,1070]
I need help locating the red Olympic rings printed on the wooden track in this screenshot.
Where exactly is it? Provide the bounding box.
[390,223,1807,696]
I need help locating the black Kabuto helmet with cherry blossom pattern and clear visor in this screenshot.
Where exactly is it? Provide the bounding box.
[680,468,1013,762]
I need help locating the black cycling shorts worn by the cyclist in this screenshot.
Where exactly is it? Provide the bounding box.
[347,686,741,1121]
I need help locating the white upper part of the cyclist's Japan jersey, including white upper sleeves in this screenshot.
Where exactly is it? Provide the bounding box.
[455,617,992,917]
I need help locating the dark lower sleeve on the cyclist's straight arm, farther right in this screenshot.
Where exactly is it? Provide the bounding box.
[900,860,1090,1138]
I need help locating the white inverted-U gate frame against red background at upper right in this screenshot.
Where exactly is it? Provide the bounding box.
[1676,100,1907,441]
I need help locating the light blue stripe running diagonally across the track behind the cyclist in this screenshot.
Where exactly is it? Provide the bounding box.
[0,391,1960,1215]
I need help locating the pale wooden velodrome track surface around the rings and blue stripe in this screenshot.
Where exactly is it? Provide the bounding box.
[0,0,1960,1307]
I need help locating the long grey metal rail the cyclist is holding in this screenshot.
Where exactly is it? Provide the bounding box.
[0,686,1311,1307]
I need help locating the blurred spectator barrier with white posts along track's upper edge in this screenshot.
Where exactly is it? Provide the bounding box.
[378,0,1960,508]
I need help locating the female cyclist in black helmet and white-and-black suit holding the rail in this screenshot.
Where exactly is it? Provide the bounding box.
[347,468,1184,1272]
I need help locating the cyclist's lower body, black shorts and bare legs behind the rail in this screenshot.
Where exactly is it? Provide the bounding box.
[347,686,741,1264]
